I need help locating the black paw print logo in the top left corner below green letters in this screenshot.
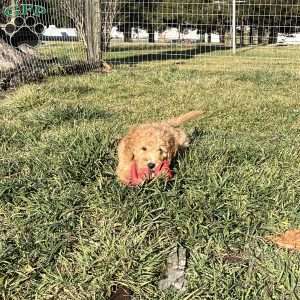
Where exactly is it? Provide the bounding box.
[4,16,45,47]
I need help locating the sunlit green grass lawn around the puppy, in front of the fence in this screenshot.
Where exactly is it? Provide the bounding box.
[0,48,300,300]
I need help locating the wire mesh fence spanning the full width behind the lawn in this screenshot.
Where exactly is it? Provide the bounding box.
[0,0,300,86]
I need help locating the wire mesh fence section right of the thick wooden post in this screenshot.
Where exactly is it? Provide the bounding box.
[103,0,300,64]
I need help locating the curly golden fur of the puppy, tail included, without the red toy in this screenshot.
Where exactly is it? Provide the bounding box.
[117,111,202,183]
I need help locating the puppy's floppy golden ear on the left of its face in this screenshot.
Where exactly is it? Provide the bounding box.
[117,136,134,183]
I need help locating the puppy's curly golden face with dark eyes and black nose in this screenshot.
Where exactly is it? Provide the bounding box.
[133,129,175,170]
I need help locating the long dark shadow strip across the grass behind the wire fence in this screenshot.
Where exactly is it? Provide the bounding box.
[106,45,231,65]
